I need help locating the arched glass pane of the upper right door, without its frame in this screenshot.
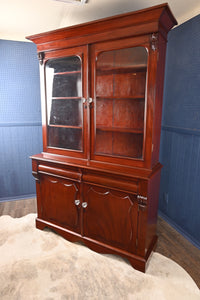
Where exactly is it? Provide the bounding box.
[95,47,148,159]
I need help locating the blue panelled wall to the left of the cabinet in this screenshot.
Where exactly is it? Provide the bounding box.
[0,40,42,201]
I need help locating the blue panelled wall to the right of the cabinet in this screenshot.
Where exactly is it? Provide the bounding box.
[159,15,200,247]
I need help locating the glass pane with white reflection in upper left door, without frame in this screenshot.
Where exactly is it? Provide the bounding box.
[45,56,83,150]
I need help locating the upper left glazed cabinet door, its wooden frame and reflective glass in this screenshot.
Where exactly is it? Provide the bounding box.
[42,47,87,158]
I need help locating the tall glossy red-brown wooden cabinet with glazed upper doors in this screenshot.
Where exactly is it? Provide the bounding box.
[28,4,176,271]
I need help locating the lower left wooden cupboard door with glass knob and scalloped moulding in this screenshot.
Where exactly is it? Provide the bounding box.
[40,175,80,232]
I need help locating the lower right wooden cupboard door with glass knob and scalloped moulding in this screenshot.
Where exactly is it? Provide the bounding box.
[83,185,137,252]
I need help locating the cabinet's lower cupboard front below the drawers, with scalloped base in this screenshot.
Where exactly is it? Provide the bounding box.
[36,173,159,271]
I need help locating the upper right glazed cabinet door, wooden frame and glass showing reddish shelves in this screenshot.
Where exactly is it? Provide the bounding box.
[91,39,148,166]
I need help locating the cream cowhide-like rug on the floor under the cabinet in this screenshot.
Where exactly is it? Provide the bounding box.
[0,214,200,300]
